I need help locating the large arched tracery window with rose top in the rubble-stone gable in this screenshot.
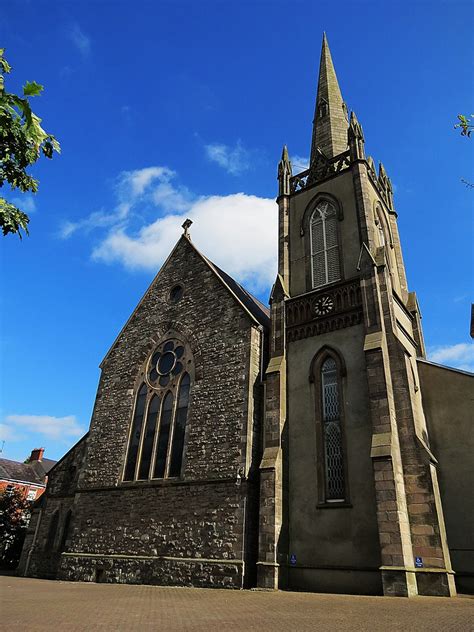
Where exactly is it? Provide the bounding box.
[123,339,193,481]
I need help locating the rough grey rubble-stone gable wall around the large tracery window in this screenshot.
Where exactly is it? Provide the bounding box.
[25,237,263,588]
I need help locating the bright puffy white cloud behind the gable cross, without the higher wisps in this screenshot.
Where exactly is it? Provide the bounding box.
[93,193,277,291]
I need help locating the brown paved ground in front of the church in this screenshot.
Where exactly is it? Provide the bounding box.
[0,577,474,632]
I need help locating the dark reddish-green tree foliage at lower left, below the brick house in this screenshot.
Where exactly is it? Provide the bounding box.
[0,487,31,568]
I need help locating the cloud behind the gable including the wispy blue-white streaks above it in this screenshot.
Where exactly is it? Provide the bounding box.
[61,166,278,291]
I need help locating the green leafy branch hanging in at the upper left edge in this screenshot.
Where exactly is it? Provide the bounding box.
[0,48,60,238]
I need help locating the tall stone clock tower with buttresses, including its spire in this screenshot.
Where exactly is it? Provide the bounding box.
[258,35,455,596]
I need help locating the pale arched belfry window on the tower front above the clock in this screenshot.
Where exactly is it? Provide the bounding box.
[310,200,341,288]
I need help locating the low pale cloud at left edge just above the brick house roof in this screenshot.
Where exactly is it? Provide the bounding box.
[2,415,84,442]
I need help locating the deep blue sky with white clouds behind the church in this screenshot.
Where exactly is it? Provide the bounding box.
[0,0,474,459]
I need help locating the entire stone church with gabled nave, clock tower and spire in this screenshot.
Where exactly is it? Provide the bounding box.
[19,37,474,597]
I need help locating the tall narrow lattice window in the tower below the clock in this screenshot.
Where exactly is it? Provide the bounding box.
[321,357,345,501]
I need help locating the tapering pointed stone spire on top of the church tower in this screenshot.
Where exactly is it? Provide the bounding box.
[310,33,348,165]
